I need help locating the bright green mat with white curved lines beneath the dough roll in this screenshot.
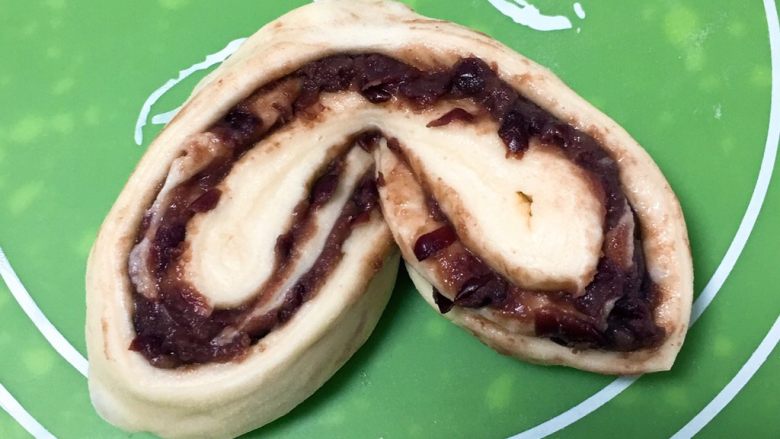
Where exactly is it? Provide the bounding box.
[0,0,780,438]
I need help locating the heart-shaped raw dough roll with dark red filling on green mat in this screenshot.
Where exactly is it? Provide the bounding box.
[86,0,692,437]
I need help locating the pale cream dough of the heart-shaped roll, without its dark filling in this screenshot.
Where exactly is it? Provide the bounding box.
[86,0,692,437]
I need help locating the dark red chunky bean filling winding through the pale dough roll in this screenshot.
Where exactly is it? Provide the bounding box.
[130,54,663,368]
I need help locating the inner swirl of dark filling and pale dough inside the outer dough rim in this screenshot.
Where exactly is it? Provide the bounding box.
[128,54,664,368]
